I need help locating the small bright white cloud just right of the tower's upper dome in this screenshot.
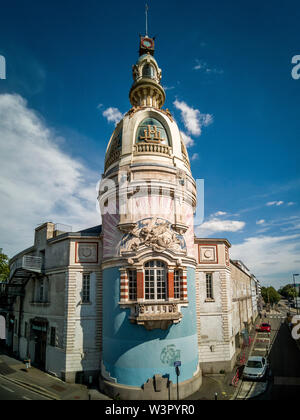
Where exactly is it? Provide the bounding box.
[174,99,213,136]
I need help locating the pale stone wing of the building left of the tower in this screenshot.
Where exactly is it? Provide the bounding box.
[2,223,102,382]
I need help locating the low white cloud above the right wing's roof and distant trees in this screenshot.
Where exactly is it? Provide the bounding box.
[230,234,300,287]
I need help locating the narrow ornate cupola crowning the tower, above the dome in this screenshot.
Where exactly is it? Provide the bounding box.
[129,36,166,108]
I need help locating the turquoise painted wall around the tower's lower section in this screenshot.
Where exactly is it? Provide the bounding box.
[103,268,198,387]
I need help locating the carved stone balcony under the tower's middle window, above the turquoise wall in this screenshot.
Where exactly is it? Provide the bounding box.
[130,302,182,330]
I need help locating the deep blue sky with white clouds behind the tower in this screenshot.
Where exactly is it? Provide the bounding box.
[0,0,300,287]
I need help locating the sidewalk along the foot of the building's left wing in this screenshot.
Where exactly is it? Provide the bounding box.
[0,351,109,401]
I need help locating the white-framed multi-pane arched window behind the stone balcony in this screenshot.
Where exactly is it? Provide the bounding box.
[145,260,167,301]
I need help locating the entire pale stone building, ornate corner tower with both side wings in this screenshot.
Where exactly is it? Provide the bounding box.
[0,37,258,400]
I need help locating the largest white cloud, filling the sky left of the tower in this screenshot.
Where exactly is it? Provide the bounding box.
[0,94,100,256]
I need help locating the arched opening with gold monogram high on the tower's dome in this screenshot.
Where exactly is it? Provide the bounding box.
[136,118,170,146]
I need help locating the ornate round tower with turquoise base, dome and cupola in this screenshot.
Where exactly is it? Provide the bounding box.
[99,36,201,400]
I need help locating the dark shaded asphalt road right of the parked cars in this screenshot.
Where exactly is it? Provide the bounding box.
[256,306,300,401]
